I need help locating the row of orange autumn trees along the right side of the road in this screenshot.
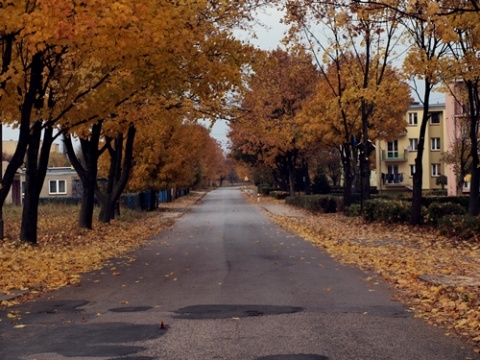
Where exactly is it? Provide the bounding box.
[231,0,480,224]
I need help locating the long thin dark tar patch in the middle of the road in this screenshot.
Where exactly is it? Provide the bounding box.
[174,305,303,320]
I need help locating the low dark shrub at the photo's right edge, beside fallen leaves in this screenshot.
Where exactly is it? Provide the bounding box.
[438,215,480,240]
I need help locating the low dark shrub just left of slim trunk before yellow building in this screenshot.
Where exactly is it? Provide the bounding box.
[363,199,410,223]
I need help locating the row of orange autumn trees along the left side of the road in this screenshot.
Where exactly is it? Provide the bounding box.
[0,0,252,243]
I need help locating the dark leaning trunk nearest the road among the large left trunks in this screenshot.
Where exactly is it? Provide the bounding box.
[97,125,136,223]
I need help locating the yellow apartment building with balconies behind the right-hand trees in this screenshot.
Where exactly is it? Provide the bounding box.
[376,103,449,192]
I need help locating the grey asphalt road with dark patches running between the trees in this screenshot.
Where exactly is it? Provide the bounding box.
[0,188,480,360]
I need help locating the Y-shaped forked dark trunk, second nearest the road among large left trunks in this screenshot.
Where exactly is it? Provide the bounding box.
[65,121,103,229]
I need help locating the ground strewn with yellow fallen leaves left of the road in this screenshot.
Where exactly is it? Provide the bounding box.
[0,192,204,306]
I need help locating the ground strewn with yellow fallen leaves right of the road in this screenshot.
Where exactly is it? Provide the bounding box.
[259,198,480,352]
